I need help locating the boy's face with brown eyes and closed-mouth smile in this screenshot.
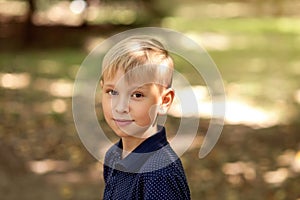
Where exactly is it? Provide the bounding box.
[102,70,163,138]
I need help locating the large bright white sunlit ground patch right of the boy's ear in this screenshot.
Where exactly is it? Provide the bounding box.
[169,86,283,128]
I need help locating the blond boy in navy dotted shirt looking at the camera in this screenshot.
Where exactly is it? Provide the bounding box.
[100,36,190,200]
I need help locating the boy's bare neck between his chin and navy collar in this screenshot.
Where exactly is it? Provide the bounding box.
[122,125,158,158]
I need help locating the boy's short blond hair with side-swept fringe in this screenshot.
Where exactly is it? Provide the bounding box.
[101,36,174,88]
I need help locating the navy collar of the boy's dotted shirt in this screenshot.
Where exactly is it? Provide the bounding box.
[115,126,169,172]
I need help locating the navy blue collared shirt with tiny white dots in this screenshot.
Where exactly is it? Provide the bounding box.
[103,127,190,200]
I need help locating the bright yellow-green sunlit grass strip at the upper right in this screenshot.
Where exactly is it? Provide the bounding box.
[163,16,300,35]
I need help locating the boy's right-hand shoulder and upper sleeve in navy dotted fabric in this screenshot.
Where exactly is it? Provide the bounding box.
[139,147,190,199]
